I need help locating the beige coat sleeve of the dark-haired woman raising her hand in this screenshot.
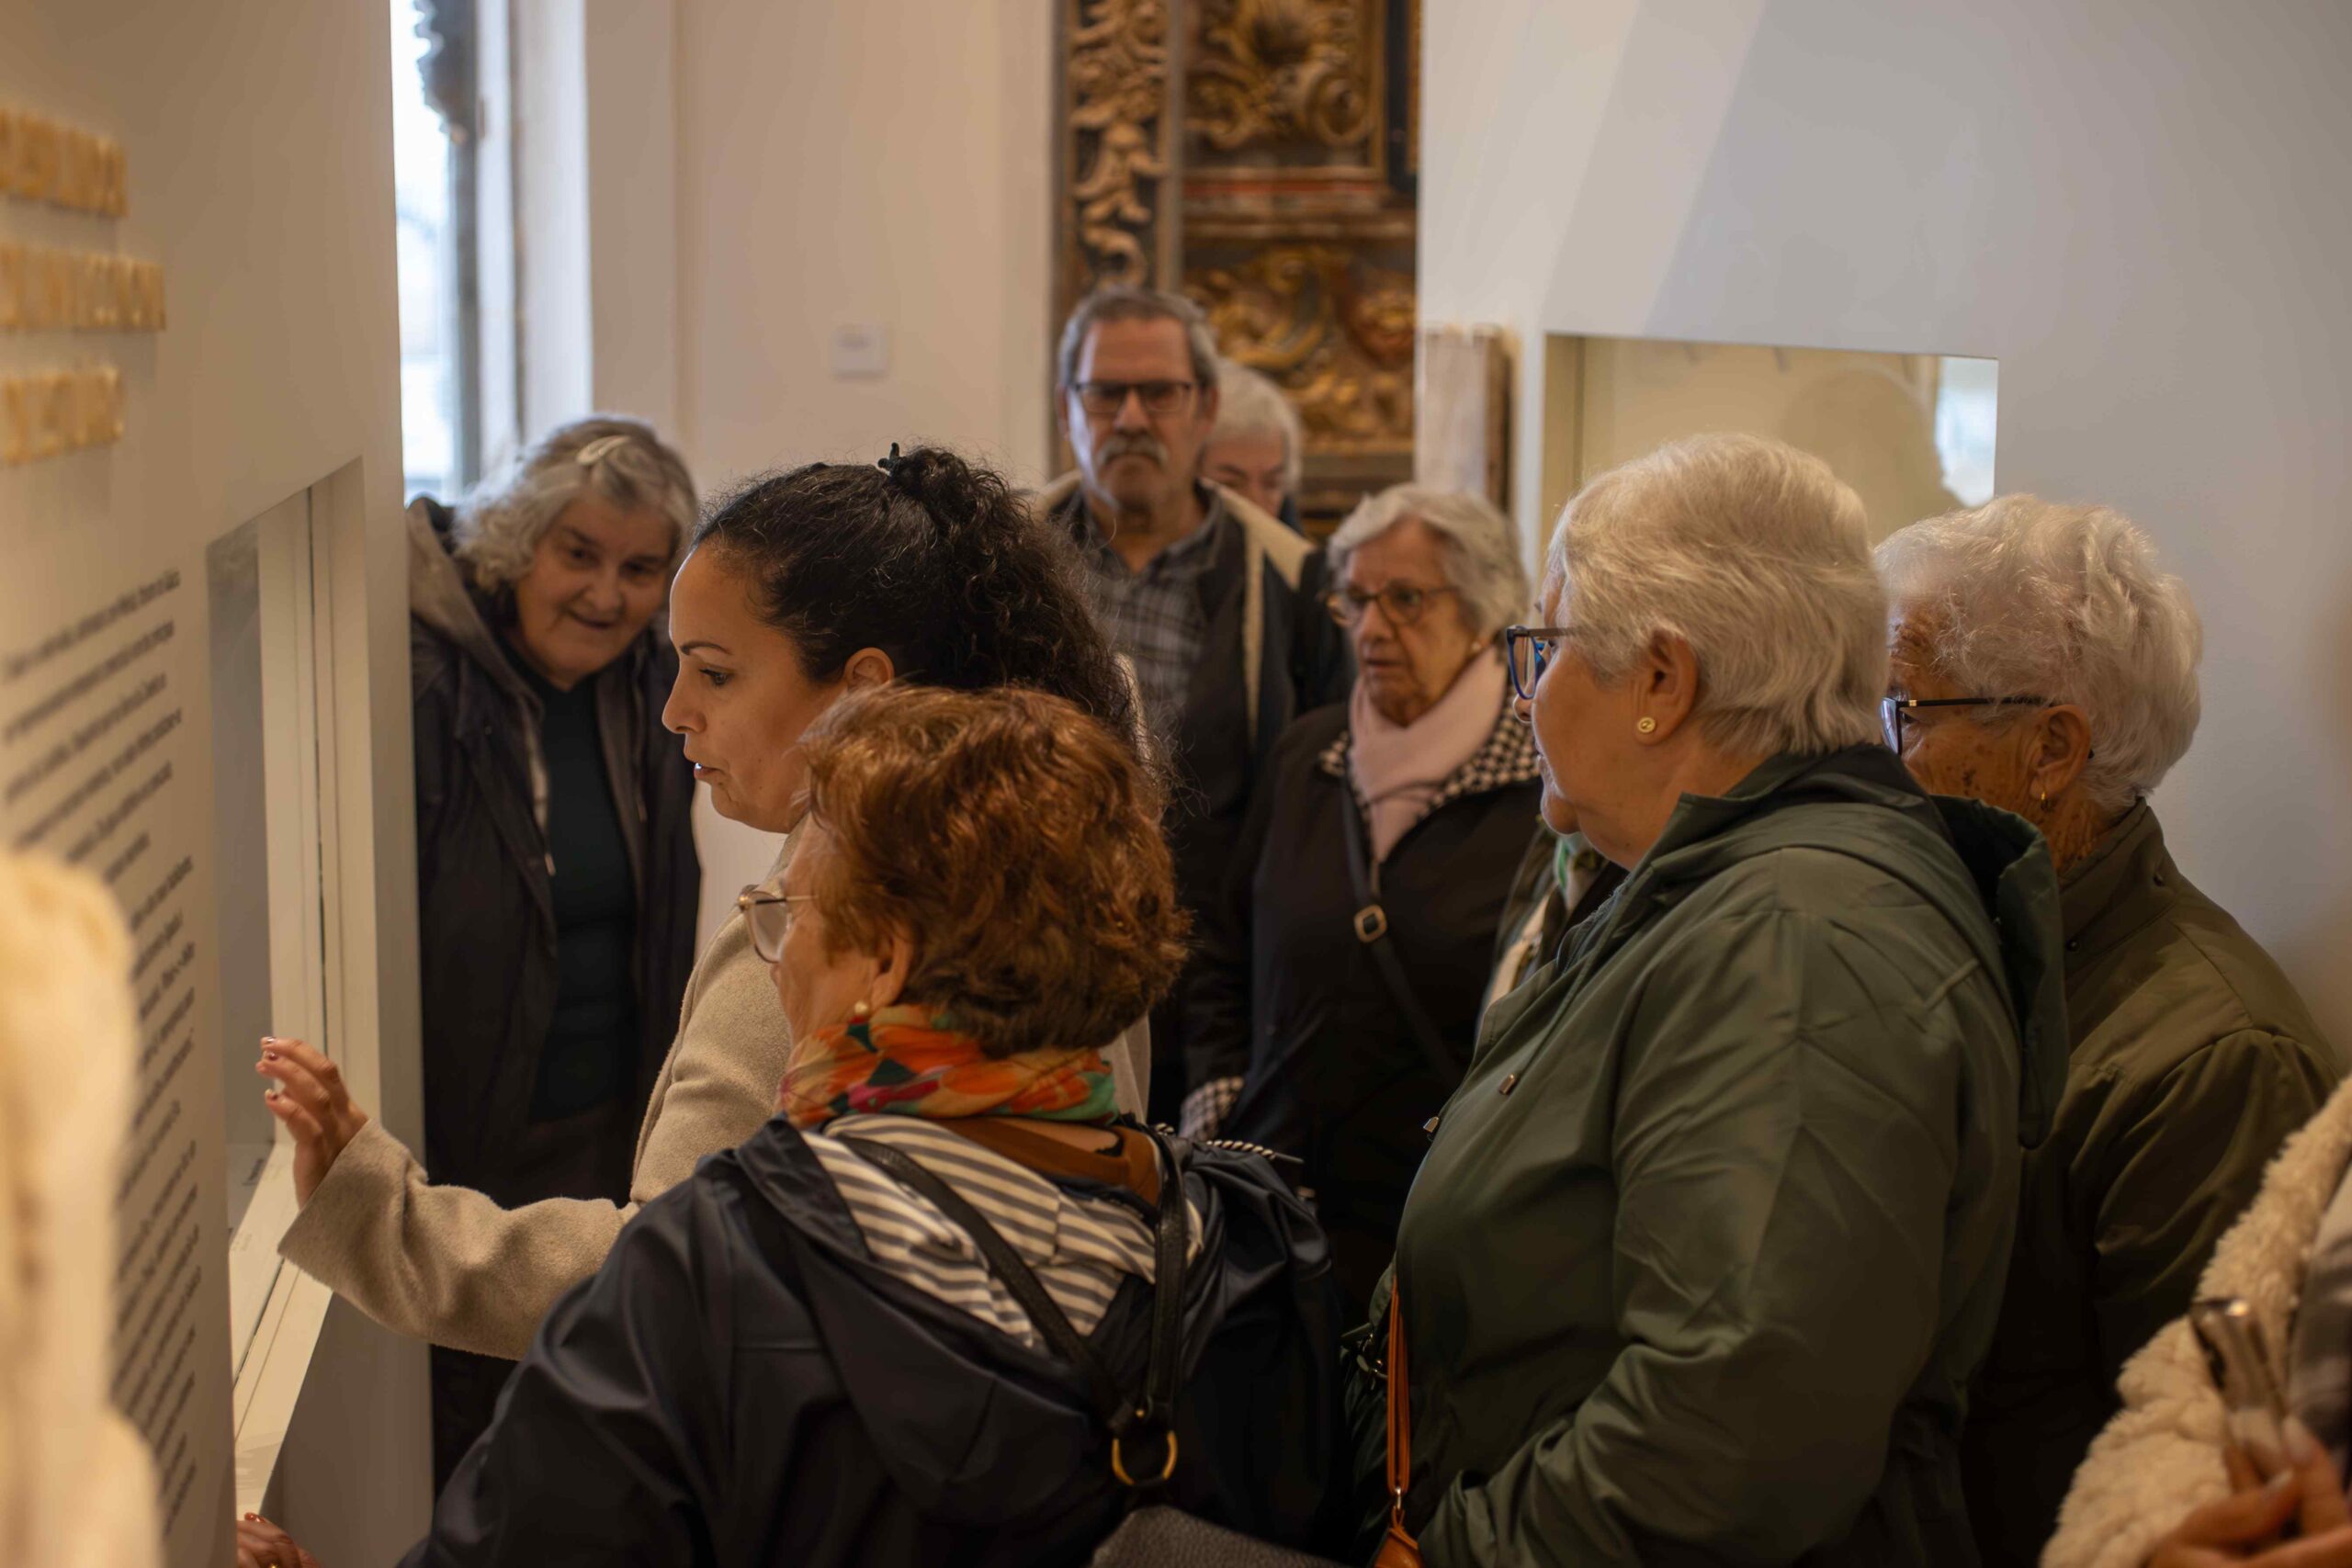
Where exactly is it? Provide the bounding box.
[277,915,790,1359]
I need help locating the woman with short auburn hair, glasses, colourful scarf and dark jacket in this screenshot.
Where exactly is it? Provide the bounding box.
[409,689,1345,1568]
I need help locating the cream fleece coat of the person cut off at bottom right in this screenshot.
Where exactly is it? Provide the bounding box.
[2041,1084,2352,1568]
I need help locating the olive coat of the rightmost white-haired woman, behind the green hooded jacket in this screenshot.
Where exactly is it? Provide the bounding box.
[1964,804,2343,1563]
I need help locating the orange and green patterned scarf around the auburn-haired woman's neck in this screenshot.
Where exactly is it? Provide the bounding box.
[776,1006,1117,1128]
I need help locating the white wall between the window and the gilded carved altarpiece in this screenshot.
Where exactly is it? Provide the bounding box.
[653,0,1054,933]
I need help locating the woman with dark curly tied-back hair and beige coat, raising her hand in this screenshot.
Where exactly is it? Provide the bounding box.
[259,449,1146,1359]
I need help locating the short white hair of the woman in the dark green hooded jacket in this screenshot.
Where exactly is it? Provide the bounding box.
[1545,434,1886,757]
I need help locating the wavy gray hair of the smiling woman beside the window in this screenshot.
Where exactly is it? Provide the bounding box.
[454,413,696,597]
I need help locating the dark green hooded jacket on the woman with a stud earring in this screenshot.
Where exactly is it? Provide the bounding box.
[1352,748,2065,1568]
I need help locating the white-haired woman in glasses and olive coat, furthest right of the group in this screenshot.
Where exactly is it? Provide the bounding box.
[1879,496,2340,1563]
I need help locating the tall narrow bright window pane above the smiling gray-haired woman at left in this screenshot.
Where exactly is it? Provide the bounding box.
[390,0,482,501]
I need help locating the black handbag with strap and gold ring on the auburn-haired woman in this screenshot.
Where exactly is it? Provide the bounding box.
[842,1134,1339,1568]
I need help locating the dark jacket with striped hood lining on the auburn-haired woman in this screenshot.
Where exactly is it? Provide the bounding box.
[407,1117,1345,1568]
